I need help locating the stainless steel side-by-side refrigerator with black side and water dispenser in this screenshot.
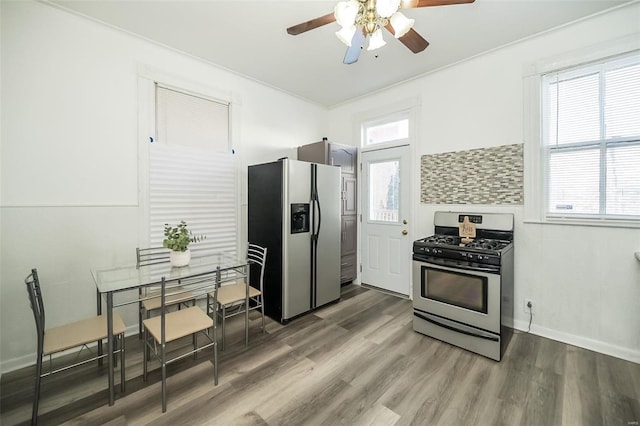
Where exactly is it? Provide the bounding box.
[248,159,340,324]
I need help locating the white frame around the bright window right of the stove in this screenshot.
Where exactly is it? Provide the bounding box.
[523,37,640,228]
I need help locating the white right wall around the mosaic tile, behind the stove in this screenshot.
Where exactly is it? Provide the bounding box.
[328,3,640,362]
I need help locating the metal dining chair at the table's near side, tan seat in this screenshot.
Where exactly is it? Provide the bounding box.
[142,274,220,413]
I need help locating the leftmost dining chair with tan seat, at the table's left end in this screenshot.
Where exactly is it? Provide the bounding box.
[24,268,126,425]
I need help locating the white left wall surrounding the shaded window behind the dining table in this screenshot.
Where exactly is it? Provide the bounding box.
[0,1,327,372]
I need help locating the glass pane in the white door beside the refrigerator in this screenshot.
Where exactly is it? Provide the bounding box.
[369,160,400,223]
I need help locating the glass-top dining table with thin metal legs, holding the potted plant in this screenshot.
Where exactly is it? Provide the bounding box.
[91,253,248,405]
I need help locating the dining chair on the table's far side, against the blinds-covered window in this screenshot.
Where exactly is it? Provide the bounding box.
[136,247,196,338]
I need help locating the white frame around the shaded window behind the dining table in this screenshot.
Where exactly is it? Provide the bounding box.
[138,67,246,254]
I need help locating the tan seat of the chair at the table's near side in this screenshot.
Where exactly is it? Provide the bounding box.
[143,306,213,342]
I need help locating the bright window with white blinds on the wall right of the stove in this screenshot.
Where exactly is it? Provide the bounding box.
[541,54,640,219]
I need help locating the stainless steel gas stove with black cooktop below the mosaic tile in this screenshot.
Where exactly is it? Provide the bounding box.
[413,212,514,361]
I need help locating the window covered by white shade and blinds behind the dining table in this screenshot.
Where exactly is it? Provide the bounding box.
[147,84,238,253]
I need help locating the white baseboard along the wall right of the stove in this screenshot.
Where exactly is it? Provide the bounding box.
[514,320,640,364]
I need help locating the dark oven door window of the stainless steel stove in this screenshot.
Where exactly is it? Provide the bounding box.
[421,266,488,314]
